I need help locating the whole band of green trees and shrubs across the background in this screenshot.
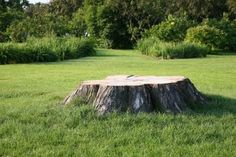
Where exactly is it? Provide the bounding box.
[0,0,236,49]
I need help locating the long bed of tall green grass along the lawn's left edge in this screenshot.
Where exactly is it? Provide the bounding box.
[0,37,96,64]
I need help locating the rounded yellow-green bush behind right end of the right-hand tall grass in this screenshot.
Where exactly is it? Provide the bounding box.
[185,25,226,49]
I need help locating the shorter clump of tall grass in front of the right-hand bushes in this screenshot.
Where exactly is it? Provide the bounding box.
[137,37,209,59]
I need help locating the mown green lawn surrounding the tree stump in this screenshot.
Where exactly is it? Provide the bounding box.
[0,50,236,157]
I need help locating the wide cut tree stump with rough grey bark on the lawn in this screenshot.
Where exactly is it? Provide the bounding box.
[64,75,204,114]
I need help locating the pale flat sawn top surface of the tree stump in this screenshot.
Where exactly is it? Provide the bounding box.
[83,75,186,86]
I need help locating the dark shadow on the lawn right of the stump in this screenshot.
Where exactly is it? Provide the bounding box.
[194,95,236,116]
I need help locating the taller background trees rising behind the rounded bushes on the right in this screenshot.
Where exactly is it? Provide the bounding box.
[0,0,236,48]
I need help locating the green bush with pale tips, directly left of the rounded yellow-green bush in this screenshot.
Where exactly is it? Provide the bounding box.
[144,15,194,42]
